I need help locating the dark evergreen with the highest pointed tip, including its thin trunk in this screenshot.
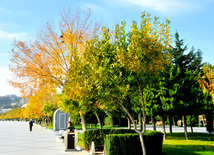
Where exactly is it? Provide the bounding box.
[172,32,204,139]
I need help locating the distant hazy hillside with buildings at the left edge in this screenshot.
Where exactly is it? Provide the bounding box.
[0,95,22,109]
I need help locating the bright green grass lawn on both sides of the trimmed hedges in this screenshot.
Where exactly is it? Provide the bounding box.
[78,133,214,155]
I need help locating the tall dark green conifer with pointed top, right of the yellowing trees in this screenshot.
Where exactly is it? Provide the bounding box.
[172,32,203,139]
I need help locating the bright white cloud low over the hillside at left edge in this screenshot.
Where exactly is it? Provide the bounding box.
[0,66,20,96]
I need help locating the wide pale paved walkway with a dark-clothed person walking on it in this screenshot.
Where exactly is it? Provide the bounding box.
[0,121,88,155]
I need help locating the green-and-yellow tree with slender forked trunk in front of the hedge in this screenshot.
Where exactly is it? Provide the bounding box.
[85,13,170,155]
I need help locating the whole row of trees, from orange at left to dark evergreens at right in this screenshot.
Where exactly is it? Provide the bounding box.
[7,10,213,154]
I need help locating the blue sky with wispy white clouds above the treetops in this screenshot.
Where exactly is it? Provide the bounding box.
[0,0,214,96]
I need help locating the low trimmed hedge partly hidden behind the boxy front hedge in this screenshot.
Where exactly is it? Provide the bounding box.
[83,129,136,150]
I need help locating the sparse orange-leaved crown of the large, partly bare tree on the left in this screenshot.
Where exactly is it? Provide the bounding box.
[10,9,99,94]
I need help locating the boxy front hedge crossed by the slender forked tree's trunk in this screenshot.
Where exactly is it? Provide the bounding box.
[104,131,163,155]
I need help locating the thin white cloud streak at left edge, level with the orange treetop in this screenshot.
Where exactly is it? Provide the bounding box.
[0,29,27,39]
